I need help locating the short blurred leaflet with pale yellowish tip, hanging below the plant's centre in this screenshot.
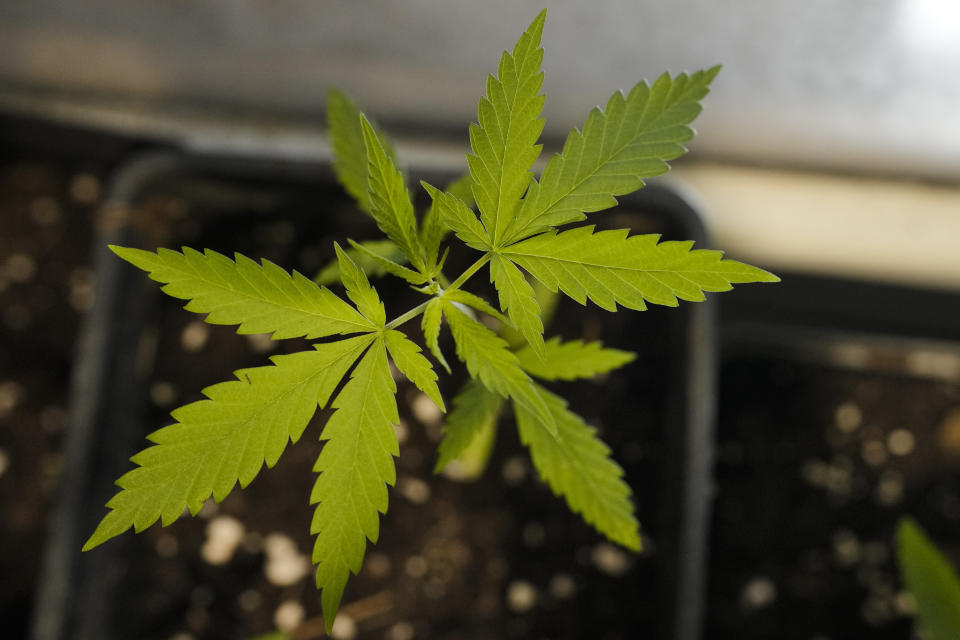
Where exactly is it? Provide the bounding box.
[434,380,504,472]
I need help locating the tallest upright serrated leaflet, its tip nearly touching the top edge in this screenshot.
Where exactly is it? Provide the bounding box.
[467,10,547,247]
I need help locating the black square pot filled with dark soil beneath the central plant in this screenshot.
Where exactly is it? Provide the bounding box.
[32,150,715,640]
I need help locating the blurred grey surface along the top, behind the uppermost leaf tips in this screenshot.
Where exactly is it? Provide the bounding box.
[0,0,960,180]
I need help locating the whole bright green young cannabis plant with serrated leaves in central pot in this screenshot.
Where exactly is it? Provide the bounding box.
[84,12,777,627]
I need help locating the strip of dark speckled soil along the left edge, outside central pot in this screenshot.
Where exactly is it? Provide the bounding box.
[0,154,102,638]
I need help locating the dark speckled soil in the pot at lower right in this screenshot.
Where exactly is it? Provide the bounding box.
[709,354,960,640]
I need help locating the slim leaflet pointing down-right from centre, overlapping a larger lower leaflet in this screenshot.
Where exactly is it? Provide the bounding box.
[443,304,557,433]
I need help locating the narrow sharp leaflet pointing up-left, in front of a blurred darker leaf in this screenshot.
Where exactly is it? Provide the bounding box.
[360,115,426,273]
